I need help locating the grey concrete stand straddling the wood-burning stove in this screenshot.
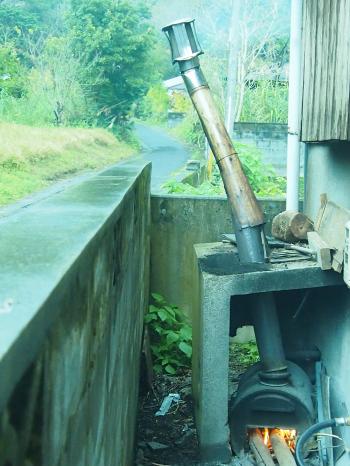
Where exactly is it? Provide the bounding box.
[192,243,344,463]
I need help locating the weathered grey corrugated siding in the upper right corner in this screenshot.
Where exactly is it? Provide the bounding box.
[301,0,350,142]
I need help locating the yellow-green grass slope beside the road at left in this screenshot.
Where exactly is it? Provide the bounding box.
[0,123,133,205]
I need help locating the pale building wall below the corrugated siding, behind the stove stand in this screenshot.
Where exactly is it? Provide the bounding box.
[301,142,350,466]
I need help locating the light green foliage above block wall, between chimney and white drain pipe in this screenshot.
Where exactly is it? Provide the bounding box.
[240,80,288,123]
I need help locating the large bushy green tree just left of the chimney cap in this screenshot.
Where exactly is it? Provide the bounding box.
[69,0,154,123]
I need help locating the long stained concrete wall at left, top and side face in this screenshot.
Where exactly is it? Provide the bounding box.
[0,162,150,466]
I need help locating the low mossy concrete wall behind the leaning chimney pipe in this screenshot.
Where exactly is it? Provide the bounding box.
[150,195,285,314]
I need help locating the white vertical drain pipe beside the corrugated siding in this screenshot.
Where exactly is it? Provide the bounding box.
[286,0,303,212]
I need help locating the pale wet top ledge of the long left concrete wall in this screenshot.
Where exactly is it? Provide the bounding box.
[0,161,150,411]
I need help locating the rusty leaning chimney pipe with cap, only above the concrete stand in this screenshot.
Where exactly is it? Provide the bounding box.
[163,19,266,263]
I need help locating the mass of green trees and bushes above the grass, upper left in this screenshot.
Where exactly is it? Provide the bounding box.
[0,0,161,129]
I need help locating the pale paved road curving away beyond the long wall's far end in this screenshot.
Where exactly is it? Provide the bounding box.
[135,124,190,192]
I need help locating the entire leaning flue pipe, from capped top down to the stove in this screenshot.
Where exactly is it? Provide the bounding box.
[163,19,288,383]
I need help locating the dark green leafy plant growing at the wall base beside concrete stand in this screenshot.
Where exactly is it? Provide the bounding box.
[145,293,192,375]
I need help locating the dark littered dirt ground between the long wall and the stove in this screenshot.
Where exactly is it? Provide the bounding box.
[135,347,254,466]
